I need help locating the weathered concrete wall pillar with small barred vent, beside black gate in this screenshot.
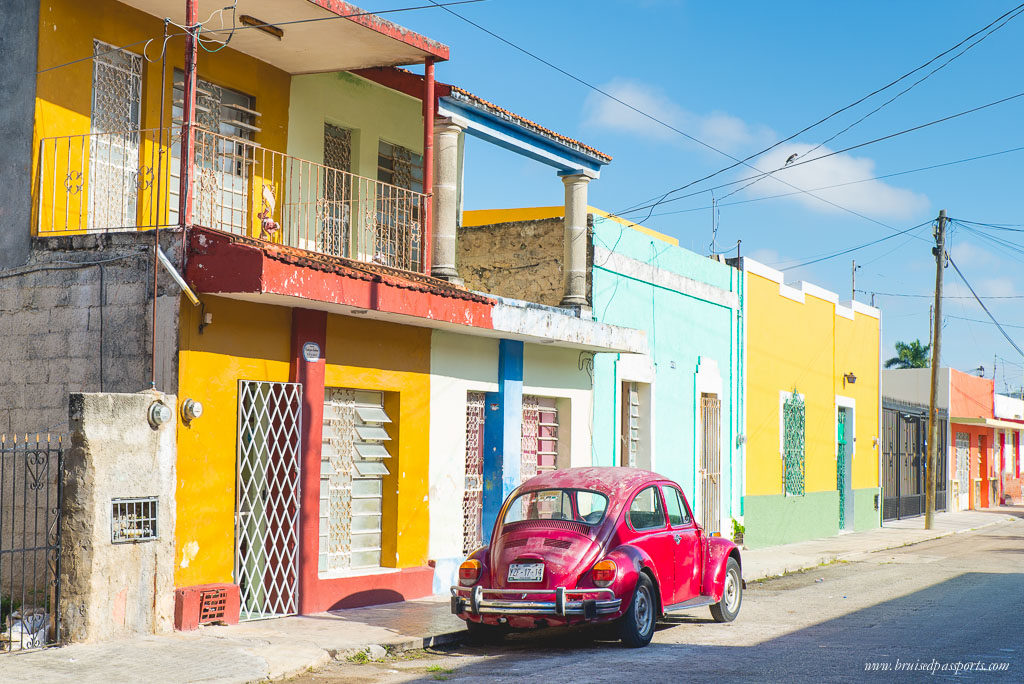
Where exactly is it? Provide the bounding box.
[60,391,176,641]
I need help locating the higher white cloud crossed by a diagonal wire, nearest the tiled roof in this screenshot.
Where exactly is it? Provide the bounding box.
[584,79,773,152]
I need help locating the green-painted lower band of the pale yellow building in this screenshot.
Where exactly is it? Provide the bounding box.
[743,489,839,549]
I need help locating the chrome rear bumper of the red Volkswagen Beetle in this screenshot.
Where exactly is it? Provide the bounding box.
[452,587,623,619]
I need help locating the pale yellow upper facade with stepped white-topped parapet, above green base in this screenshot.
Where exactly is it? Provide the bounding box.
[744,271,879,496]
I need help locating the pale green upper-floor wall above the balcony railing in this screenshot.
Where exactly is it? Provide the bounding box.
[288,72,423,178]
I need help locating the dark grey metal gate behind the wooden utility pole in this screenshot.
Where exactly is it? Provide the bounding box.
[882,407,947,520]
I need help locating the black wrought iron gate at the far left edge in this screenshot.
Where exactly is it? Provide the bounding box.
[0,436,63,652]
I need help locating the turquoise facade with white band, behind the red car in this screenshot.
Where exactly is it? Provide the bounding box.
[593,216,741,535]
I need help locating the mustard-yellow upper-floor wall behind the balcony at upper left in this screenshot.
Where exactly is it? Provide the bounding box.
[33,0,291,231]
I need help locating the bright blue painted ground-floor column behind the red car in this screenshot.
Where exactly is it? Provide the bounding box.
[481,340,523,544]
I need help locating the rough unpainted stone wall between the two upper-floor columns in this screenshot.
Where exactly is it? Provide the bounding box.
[456,218,564,306]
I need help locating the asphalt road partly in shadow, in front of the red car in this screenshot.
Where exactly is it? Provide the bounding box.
[293,520,1024,684]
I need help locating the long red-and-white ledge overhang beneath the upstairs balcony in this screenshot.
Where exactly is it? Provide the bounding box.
[185,228,647,353]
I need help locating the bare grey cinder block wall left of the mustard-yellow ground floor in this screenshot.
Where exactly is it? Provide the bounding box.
[0,230,181,434]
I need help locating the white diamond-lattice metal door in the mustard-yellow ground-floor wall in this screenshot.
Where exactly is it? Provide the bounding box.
[234,380,302,621]
